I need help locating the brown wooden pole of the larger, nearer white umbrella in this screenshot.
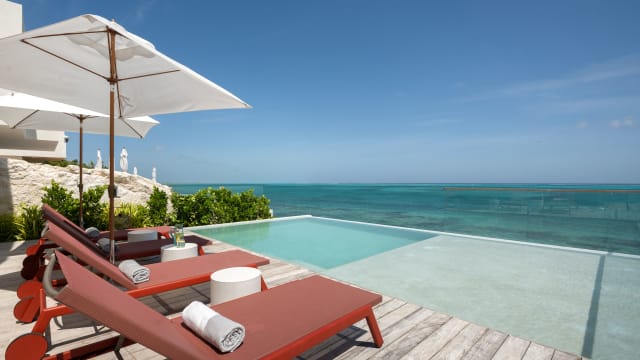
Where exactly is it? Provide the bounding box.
[107,29,118,264]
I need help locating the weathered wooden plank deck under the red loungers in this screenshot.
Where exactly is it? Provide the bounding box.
[0,238,582,360]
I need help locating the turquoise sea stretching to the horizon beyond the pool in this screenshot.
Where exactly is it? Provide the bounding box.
[171,184,640,255]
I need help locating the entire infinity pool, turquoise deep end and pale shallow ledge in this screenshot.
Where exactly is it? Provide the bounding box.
[190,217,640,360]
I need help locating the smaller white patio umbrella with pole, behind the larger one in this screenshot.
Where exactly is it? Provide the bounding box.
[0,88,159,227]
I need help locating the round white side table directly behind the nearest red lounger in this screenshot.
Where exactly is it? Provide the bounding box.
[210,267,261,305]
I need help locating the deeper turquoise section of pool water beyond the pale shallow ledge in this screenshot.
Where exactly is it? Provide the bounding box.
[193,217,433,271]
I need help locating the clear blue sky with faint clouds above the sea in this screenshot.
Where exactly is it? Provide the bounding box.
[18,0,640,183]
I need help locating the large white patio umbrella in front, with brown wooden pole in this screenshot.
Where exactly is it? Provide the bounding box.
[0,15,249,261]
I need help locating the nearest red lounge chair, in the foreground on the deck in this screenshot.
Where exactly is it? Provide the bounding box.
[7,251,382,359]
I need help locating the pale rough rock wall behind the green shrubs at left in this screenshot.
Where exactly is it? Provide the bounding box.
[0,158,171,214]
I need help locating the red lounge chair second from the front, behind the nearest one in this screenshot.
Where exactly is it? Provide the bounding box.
[8,223,269,356]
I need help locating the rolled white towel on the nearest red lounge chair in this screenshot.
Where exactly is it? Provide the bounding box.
[182,301,244,352]
